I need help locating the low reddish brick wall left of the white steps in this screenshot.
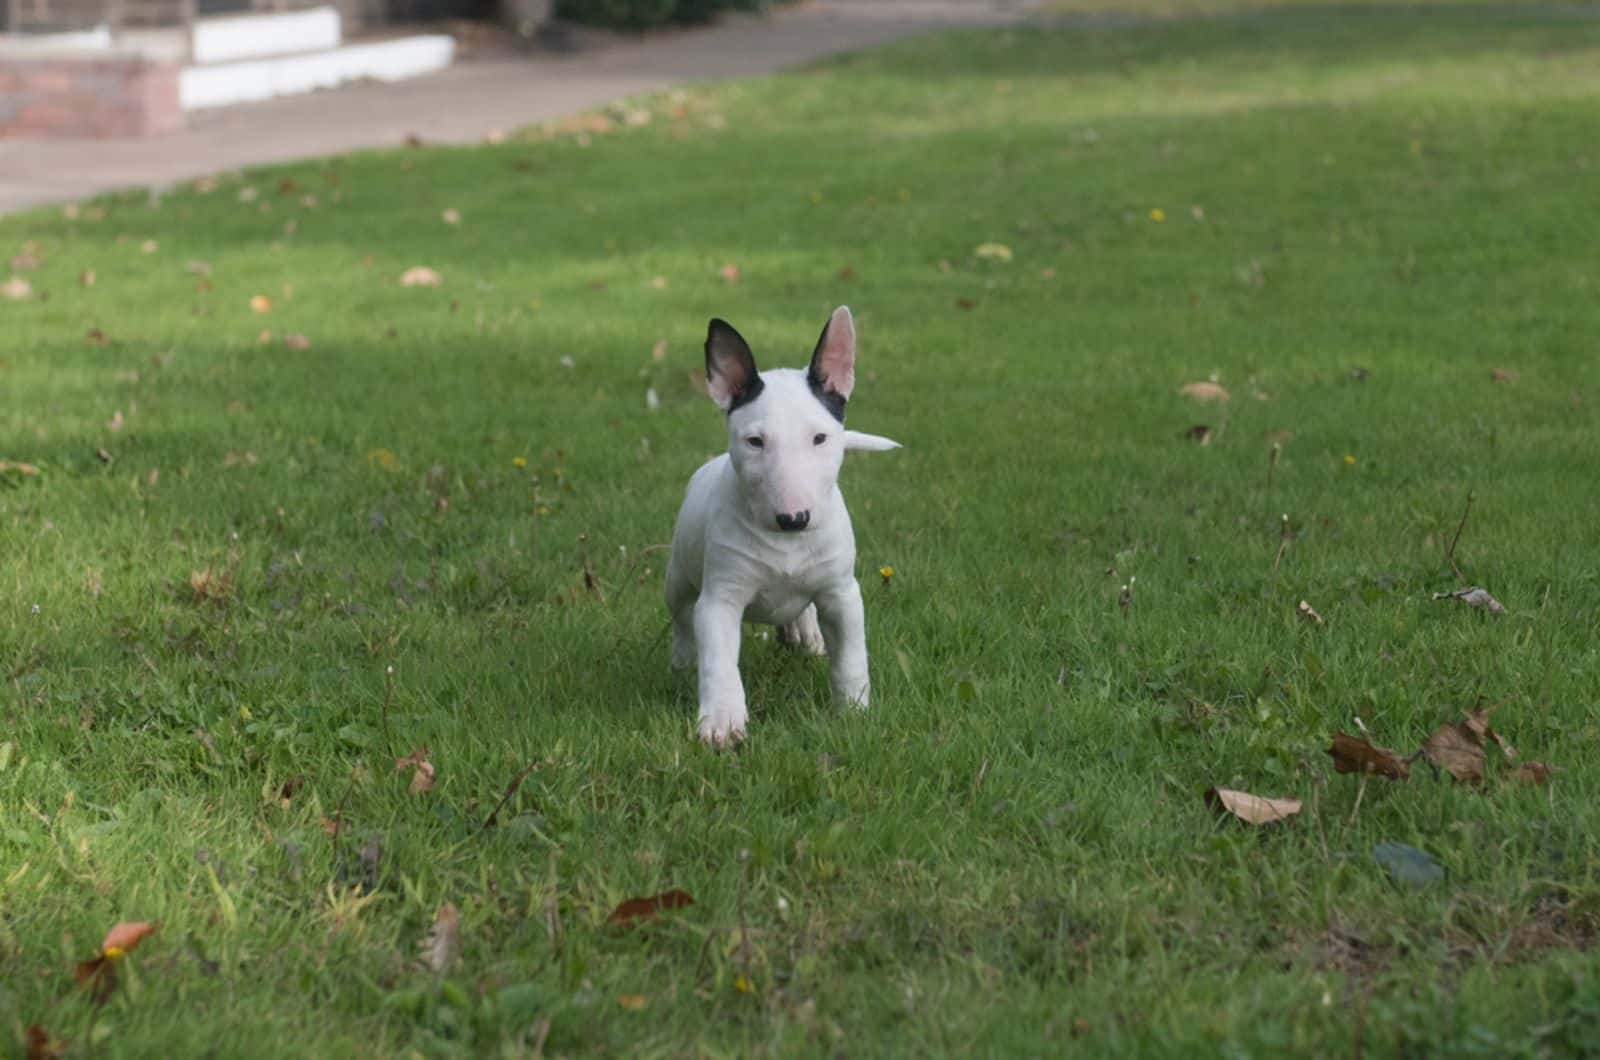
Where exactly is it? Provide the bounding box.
[0,56,184,139]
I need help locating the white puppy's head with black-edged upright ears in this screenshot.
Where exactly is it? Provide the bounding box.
[706,306,896,532]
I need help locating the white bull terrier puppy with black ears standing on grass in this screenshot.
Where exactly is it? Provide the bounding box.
[667,306,899,746]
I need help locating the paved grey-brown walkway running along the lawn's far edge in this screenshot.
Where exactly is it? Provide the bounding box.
[0,0,1034,215]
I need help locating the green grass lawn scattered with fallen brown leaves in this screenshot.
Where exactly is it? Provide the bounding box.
[0,10,1600,1057]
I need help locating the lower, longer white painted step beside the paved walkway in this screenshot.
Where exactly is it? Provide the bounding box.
[178,34,456,110]
